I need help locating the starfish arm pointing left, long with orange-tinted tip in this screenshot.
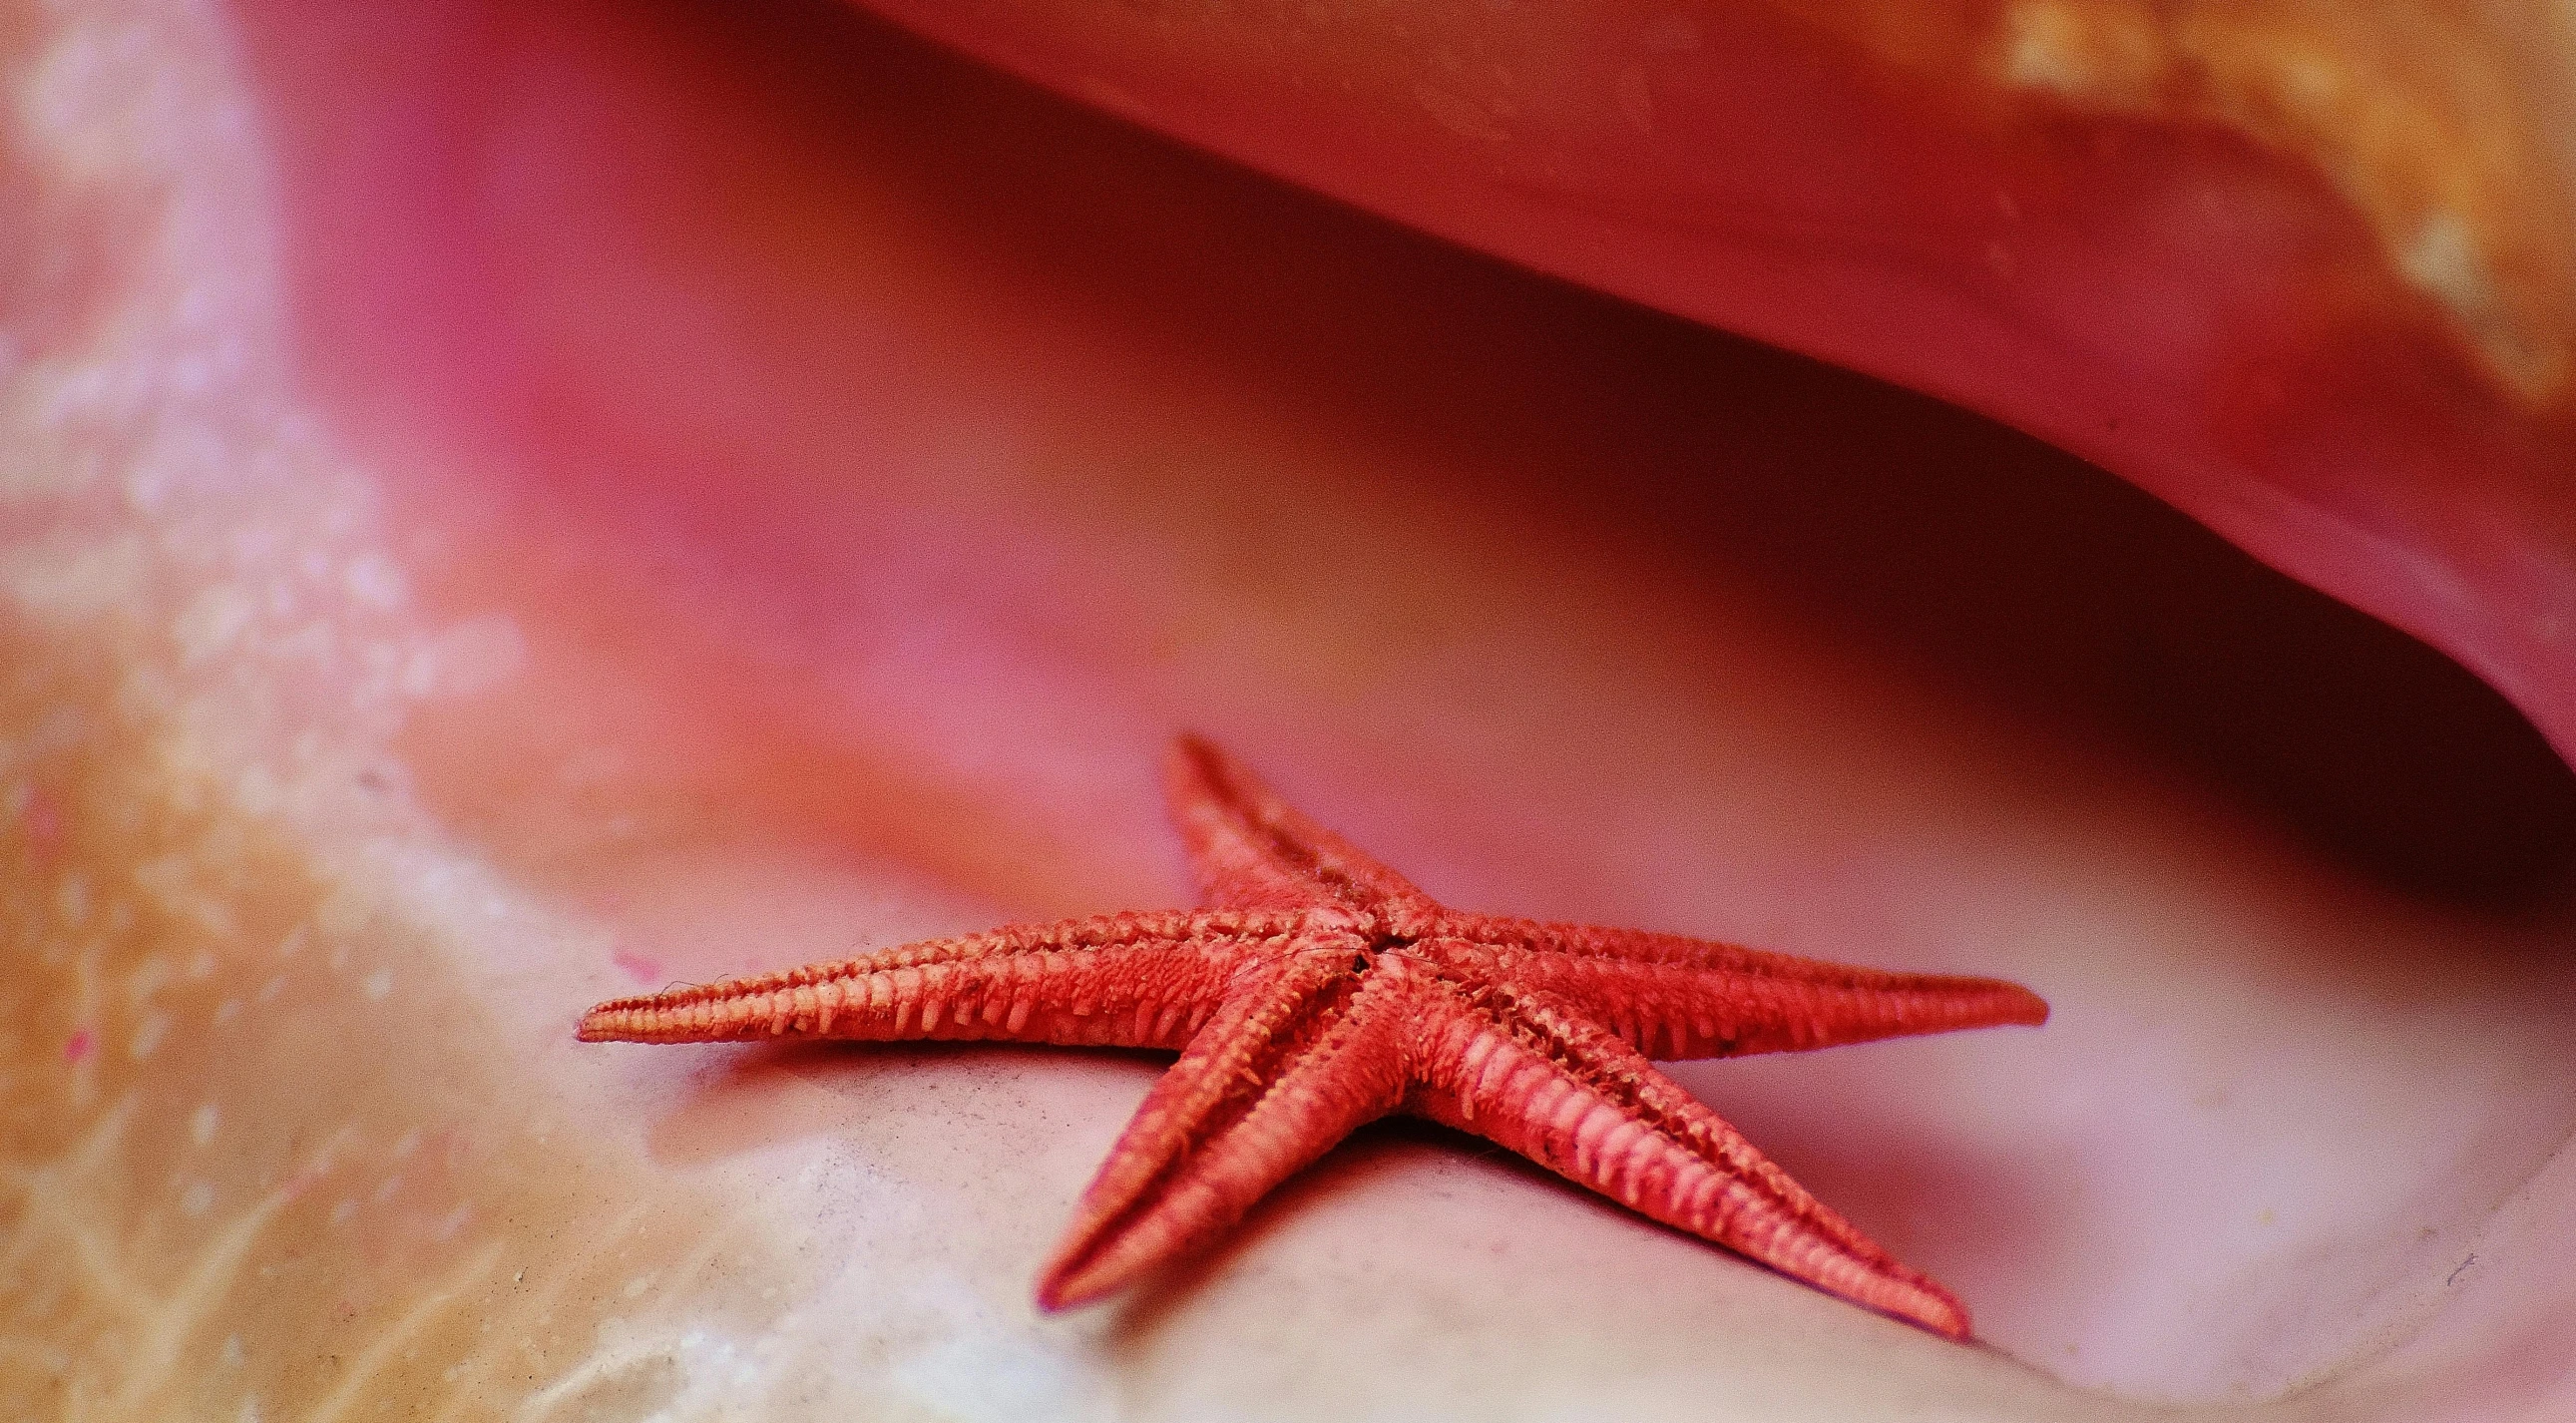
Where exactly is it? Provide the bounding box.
[580,910,1309,1049]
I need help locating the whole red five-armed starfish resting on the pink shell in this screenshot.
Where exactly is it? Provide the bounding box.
[583,739,2048,1338]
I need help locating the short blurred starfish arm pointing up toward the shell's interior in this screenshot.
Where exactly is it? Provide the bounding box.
[1164,737,1435,910]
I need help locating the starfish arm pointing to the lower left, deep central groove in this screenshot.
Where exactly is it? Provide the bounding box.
[1039,936,1404,1309]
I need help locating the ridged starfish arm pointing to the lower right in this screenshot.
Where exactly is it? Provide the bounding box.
[1407,990,1968,1338]
